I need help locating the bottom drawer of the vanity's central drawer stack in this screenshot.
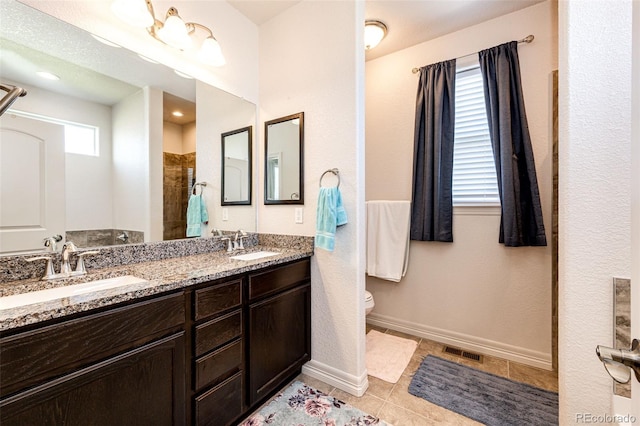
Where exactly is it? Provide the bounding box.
[195,371,243,426]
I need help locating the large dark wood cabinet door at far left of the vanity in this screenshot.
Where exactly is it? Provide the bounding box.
[0,333,186,426]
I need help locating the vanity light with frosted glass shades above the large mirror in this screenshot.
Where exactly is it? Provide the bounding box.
[111,0,226,67]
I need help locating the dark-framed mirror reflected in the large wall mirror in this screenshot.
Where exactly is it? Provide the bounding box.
[221,126,253,206]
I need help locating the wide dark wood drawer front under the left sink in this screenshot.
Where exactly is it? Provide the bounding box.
[0,293,185,396]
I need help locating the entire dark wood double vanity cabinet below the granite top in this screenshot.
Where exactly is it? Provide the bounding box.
[0,255,311,426]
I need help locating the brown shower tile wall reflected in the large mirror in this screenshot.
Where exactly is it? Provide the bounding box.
[163,152,196,240]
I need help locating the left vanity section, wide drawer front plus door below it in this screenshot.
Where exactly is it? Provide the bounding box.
[0,293,186,426]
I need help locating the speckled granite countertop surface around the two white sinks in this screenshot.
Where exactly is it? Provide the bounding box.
[0,245,313,331]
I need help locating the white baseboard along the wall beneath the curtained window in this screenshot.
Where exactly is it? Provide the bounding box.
[367,312,553,371]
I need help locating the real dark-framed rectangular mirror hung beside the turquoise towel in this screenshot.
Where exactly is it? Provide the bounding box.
[264,112,304,204]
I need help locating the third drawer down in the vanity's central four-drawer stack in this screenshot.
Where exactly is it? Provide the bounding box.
[195,339,242,391]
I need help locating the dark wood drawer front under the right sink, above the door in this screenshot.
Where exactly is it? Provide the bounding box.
[249,259,311,300]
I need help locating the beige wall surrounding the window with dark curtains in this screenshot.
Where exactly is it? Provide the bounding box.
[366,2,557,368]
